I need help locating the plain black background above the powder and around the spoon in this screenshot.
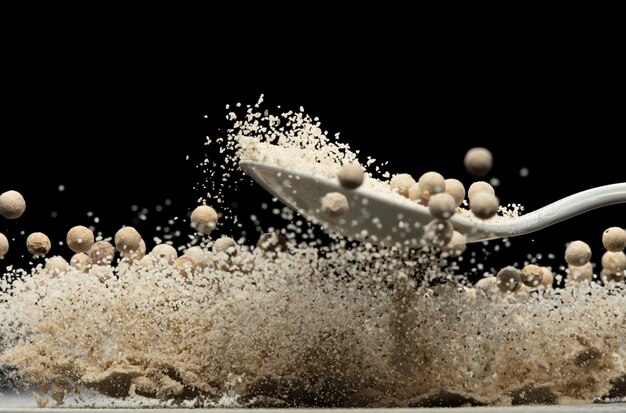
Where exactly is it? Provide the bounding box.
[0,5,626,276]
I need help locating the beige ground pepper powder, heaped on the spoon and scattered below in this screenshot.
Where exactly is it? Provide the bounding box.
[0,99,626,407]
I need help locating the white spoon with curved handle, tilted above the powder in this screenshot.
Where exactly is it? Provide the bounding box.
[239,160,626,247]
